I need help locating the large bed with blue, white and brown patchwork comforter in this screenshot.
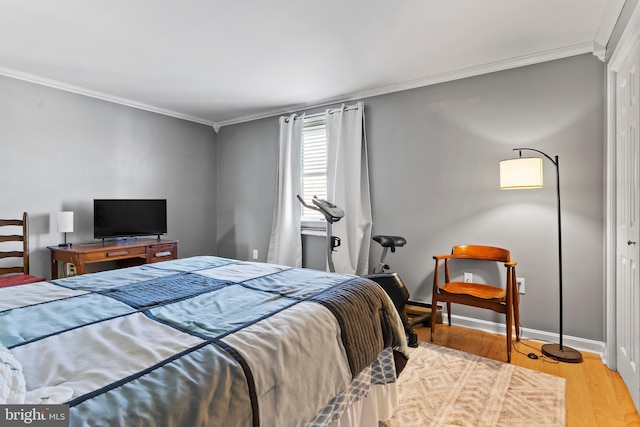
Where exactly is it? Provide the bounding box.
[0,256,407,427]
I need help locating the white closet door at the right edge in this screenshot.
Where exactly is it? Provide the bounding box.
[616,38,640,410]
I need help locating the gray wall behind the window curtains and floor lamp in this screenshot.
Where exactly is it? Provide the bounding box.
[218,55,605,341]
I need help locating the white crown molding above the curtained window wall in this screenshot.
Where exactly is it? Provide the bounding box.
[216,42,594,128]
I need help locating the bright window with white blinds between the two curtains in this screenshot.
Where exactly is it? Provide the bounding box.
[300,114,327,228]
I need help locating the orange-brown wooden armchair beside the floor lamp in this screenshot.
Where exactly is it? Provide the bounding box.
[431,245,520,362]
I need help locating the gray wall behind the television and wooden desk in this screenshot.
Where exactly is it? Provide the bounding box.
[0,77,217,277]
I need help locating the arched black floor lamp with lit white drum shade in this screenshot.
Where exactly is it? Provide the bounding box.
[500,148,582,363]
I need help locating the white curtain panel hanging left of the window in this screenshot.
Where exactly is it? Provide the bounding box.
[267,114,304,267]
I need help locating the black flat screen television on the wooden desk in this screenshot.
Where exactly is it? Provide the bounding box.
[93,199,167,239]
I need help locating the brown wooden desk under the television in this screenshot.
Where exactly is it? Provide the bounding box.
[48,239,178,279]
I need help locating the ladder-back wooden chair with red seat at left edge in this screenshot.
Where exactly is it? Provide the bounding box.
[0,212,45,287]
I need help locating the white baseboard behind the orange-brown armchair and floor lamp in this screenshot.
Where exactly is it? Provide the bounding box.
[451,314,607,365]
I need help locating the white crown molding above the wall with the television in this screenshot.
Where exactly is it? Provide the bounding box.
[0,67,219,129]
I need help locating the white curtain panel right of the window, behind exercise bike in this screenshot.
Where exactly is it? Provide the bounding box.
[326,102,372,275]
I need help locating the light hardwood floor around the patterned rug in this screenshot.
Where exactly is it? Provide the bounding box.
[414,324,640,427]
